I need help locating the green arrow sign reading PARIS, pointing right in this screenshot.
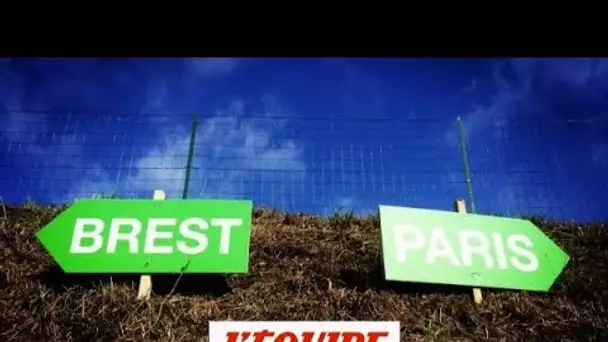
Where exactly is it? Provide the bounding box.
[380,205,569,291]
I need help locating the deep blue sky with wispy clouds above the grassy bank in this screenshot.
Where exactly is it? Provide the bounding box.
[0,58,608,220]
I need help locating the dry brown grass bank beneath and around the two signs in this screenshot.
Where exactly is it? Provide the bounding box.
[0,206,608,341]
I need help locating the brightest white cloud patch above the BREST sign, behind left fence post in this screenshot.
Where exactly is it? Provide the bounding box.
[59,100,306,200]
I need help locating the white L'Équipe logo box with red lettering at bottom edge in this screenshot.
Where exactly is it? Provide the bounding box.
[209,321,400,342]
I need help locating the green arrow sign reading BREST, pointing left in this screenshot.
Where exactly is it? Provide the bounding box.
[38,199,253,274]
